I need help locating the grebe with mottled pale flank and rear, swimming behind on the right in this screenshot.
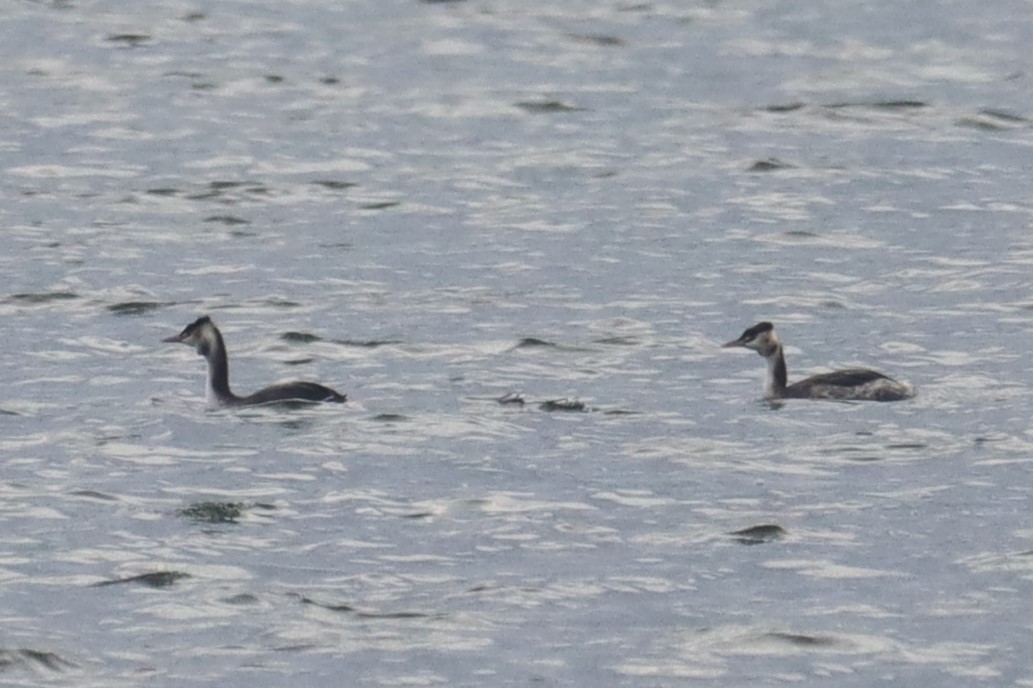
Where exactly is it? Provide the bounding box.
[724,322,914,401]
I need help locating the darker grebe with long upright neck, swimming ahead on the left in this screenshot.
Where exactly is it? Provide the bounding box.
[161,315,347,406]
